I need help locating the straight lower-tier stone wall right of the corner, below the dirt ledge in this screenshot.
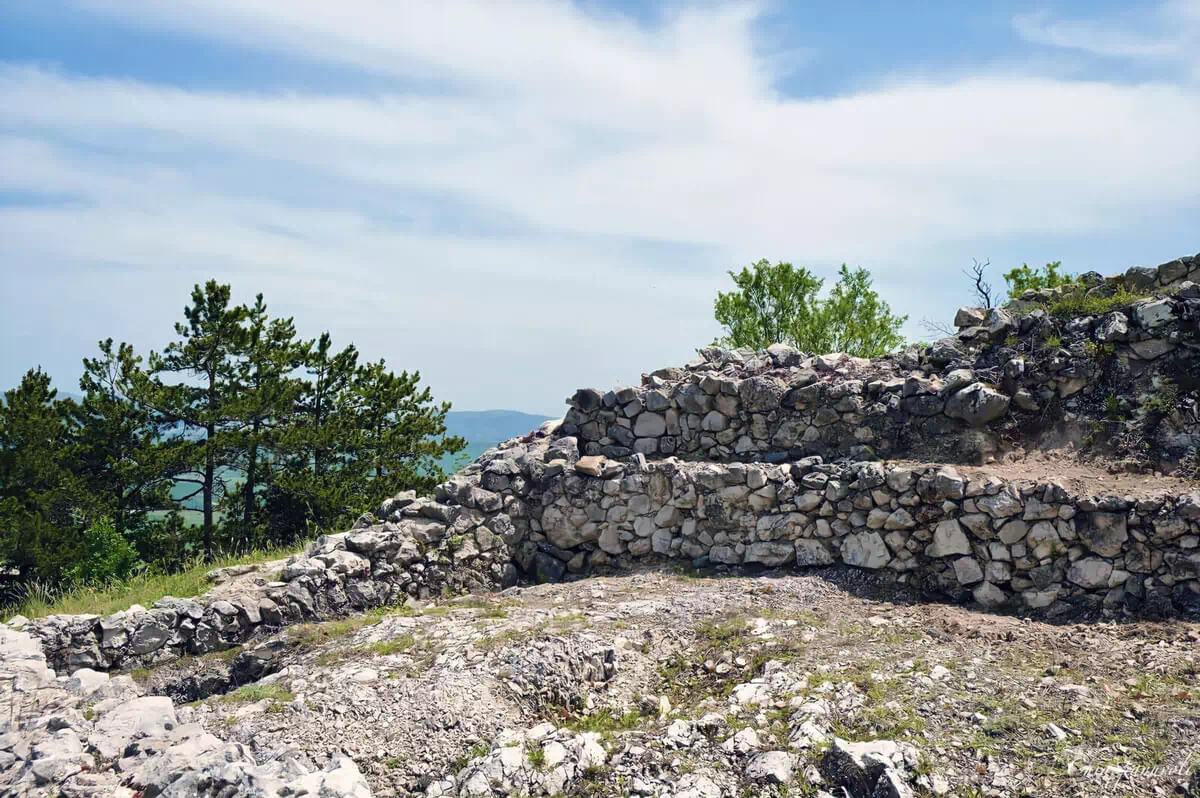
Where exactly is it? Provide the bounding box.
[541,457,1200,614]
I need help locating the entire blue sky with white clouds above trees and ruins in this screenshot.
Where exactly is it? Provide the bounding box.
[0,0,1200,415]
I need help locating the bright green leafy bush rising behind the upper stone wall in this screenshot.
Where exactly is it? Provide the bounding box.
[714,260,907,358]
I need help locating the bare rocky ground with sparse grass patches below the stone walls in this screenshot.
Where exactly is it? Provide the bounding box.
[114,570,1200,798]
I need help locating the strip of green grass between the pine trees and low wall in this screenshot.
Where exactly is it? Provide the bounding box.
[4,548,304,620]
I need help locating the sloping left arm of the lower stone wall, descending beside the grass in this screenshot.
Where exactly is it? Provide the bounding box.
[19,468,528,672]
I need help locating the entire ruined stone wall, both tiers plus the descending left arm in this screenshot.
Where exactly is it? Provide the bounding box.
[13,250,1200,670]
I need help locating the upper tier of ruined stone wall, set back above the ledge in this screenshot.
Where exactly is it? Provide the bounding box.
[564,258,1200,463]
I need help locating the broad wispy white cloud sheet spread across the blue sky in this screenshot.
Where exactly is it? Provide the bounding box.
[0,0,1200,409]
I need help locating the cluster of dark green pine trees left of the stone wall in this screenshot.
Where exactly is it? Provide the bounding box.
[0,281,466,596]
